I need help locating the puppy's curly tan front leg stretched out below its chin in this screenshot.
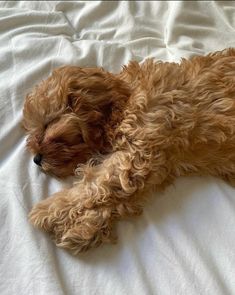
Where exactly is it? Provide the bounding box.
[30,151,164,253]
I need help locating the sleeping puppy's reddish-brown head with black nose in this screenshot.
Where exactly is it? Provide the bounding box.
[22,66,130,177]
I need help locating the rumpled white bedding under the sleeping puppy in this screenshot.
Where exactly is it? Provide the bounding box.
[0,1,235,295]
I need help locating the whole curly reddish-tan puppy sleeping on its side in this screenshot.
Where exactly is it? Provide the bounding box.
[23,49,235,253]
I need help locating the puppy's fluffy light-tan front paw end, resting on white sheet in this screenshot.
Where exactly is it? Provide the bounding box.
[29,191,113,254]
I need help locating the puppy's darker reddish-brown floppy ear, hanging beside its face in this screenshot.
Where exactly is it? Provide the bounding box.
[68,68,130,148]
